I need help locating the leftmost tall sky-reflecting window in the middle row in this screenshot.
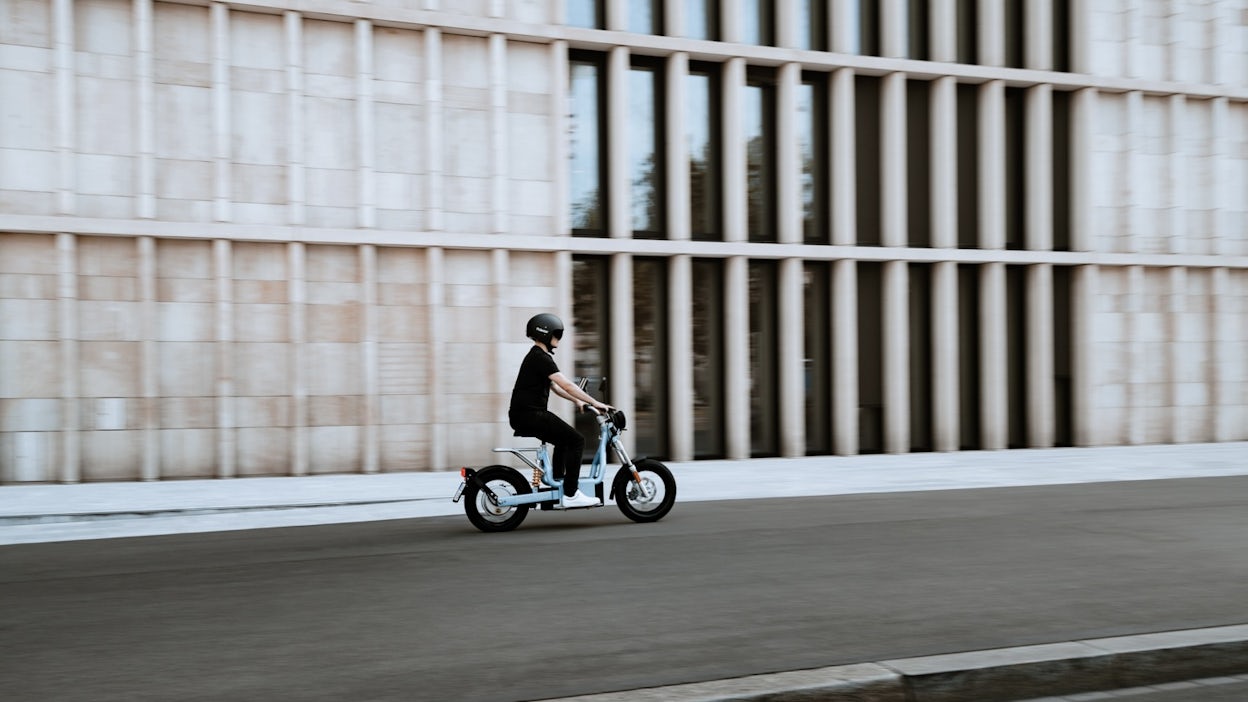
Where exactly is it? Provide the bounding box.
[568,52,607,236]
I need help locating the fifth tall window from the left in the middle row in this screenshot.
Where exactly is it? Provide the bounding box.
[797,75,830,244]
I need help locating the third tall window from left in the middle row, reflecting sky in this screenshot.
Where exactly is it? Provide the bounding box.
[685,66,723,241]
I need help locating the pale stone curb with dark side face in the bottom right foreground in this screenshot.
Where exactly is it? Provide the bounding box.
[548,625,1248,702]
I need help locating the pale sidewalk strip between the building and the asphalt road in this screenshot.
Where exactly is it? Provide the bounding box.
[0,442,1248,545]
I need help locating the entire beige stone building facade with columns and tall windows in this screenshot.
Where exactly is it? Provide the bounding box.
[0,0,1248,482]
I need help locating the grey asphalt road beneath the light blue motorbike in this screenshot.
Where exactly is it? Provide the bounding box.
[0,477,1248,702]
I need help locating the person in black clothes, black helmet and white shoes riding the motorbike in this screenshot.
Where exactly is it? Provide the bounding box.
[507,314,610,508]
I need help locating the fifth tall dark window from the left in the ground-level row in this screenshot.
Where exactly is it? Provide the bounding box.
[802,261,832,456]
